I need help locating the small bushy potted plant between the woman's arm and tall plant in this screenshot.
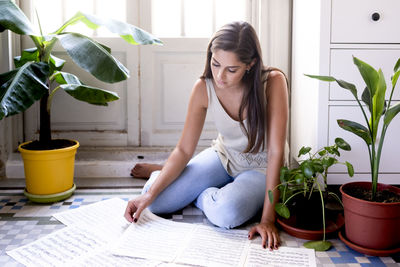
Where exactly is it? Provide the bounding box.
[268,138,354,251]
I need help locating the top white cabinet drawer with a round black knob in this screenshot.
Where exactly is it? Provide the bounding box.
[331,0,400,43]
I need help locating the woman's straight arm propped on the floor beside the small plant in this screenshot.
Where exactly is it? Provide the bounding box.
[249,71,289,249]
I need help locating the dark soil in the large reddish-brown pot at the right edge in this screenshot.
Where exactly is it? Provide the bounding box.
[345,187,400,203]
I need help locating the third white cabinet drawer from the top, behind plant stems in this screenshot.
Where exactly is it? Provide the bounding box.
[328,106,400,173]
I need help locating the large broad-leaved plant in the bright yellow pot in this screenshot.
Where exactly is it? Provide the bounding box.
[0,0,162,202]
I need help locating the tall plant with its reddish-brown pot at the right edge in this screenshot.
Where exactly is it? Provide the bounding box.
[307,57,400,255]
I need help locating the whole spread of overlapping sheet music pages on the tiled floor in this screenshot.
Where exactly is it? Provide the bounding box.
[7,198,316,267]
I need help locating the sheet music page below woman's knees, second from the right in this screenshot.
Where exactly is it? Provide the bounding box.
[176,225,250,266]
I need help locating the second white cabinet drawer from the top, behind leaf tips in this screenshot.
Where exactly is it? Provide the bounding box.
[330,49,400,100]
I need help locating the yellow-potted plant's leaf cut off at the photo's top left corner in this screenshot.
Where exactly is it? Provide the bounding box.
[0,0,38,36]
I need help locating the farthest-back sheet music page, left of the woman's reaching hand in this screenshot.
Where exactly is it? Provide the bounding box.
[53,198,128,227]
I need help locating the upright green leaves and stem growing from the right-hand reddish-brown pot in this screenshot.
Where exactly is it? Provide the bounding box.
[307,57,400,200]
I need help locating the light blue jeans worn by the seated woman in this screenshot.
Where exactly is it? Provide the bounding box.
[142,148,265,228]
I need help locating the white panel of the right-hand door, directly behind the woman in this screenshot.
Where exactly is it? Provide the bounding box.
[140,38,216,146]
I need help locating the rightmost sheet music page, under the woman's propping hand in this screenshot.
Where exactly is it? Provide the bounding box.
[245,243,317,267]
